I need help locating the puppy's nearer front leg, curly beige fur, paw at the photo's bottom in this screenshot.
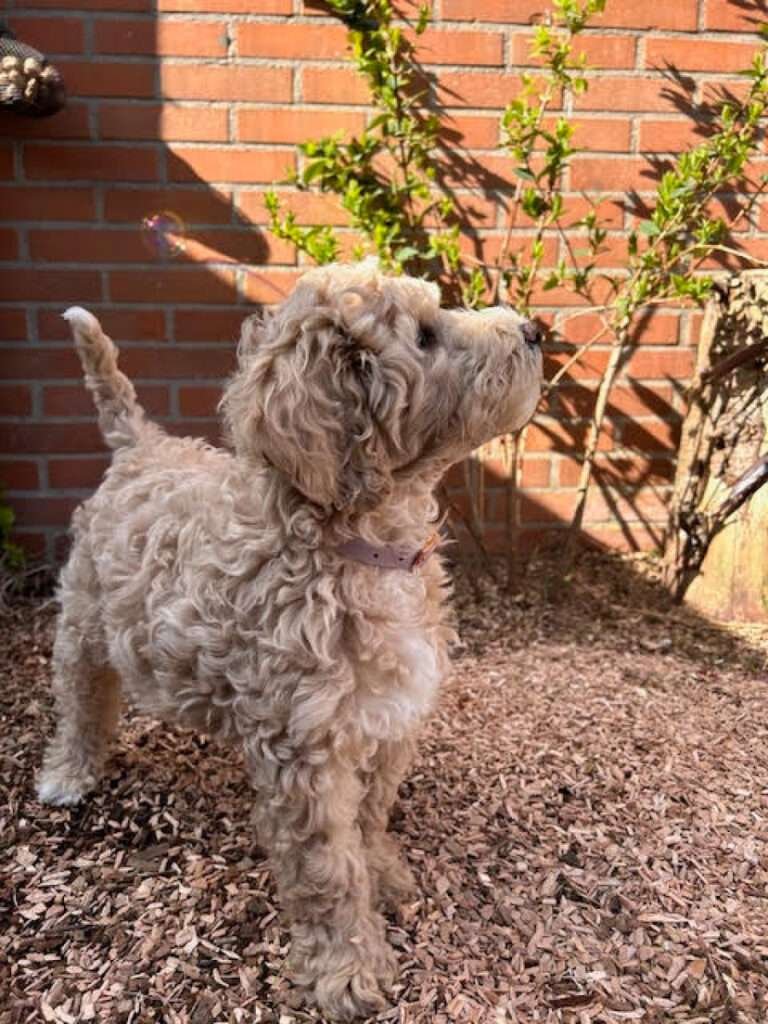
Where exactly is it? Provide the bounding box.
[250,752,395,1020]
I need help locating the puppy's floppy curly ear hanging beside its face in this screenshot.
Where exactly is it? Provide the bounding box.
[222,285,391,509]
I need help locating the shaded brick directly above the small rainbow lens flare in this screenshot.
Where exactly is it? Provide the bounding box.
[104,185,232,227]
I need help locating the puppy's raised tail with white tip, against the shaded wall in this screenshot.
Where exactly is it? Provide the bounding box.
[63,306,146,449]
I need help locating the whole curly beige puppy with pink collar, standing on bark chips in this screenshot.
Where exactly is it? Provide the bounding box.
[38,262,541,1018]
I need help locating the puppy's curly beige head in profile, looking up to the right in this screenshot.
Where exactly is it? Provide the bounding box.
[222,260,542,511]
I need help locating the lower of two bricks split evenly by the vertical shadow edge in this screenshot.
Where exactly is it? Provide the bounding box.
[98,103,229,142]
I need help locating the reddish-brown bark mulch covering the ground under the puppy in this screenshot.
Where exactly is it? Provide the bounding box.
[0,557,768,1024]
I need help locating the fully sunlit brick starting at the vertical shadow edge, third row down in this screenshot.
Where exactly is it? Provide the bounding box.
[160,63,290,103]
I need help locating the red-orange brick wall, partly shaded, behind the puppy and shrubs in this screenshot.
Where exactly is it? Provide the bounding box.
[0,0,768,558]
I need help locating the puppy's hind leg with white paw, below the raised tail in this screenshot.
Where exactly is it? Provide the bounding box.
[37,550,120,805]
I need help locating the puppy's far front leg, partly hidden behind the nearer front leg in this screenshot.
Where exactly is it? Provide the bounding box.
[359,739,416,907]
